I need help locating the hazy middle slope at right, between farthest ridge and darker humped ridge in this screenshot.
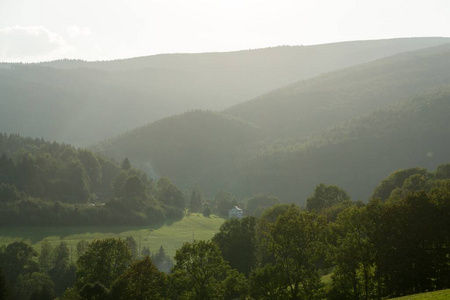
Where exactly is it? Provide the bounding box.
[224,44,450,139]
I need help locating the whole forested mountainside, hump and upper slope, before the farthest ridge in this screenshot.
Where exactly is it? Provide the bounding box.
[93,45,450,204]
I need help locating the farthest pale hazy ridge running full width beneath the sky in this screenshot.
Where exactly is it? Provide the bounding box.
[0,38,449,146]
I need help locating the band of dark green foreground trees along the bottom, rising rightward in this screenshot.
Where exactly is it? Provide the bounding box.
[0,164,450,299]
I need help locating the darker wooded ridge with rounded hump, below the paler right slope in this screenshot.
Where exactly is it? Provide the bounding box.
[95,86,450,204]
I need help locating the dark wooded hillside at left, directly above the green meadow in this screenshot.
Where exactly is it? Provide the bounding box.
[0,134,185,225]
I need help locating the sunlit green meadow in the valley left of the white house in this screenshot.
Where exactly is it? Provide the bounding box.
[0,214,224,258]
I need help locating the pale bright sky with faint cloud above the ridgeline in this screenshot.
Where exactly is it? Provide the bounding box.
[0,0,450,62]
